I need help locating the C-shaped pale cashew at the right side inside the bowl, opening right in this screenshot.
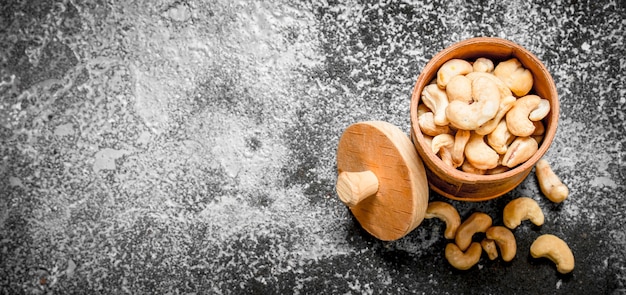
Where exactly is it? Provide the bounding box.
[506,94,541,136]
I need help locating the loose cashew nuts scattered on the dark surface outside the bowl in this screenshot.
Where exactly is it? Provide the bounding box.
[425,159,574,274]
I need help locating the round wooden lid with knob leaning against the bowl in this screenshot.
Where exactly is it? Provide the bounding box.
[337,121,428,241]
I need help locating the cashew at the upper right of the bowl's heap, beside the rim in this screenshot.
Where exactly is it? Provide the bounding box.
[493,58,533,96]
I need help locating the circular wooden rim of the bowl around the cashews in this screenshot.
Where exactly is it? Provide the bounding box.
[410,37,559,183]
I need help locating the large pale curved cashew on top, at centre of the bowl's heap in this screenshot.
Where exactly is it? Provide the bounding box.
[446,77,500,130]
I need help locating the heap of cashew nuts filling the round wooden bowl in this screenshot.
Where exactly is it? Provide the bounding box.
[417,57,550,174]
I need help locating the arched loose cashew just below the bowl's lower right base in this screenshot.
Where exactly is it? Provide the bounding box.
[502,197,544,229]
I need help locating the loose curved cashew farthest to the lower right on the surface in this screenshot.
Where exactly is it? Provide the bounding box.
[530,234,574,274]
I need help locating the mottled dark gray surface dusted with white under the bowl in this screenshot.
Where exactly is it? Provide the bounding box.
[0,0,626,294]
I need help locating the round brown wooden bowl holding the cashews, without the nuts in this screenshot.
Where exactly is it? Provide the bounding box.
[411,37,559,201]
